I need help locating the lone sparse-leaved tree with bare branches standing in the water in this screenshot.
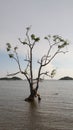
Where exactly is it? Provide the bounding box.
[6,27,69,101]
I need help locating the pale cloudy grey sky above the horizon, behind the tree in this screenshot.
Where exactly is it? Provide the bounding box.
[0,0,73,79]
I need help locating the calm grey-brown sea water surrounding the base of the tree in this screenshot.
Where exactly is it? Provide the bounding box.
[0,81,73,130]
